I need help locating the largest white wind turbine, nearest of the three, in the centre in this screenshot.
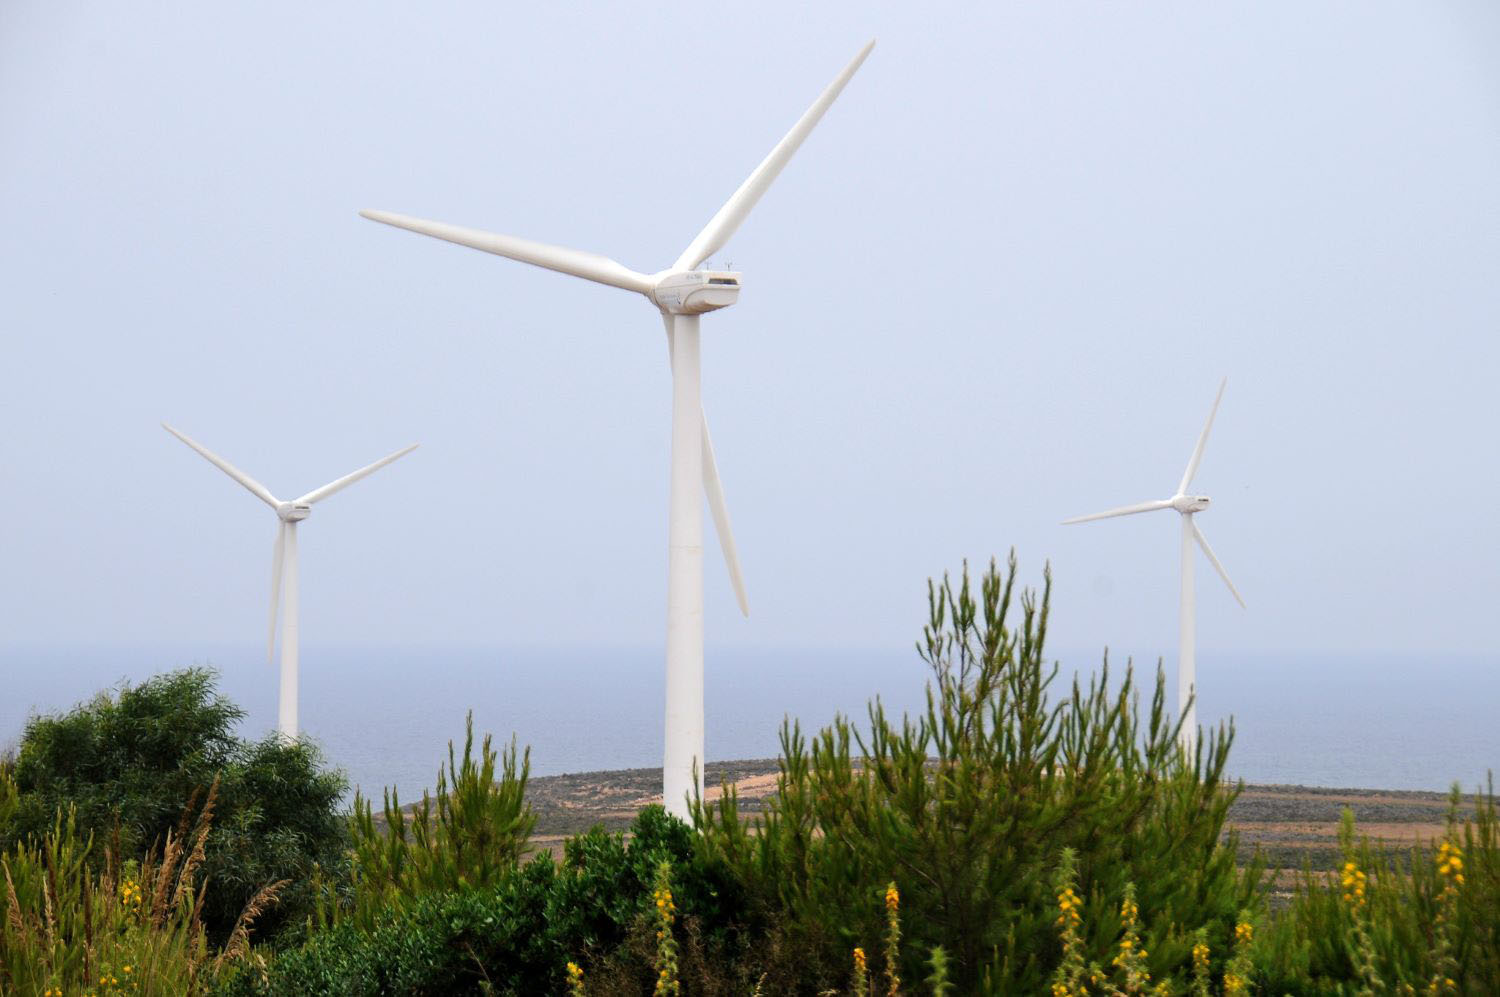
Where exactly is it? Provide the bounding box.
[360,40,875,817]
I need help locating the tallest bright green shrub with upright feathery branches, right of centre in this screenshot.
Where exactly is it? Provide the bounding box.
[695,558,1260,993]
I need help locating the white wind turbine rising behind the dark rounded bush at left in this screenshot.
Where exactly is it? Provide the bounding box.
[162,423,419,741]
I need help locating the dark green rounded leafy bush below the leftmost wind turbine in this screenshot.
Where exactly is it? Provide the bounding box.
[0,669,348,942]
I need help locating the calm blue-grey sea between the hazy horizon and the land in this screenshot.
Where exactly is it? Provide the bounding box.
[0,646,1500,799]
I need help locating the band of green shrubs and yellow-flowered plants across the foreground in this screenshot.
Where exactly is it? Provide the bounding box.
[0,561,1500,997]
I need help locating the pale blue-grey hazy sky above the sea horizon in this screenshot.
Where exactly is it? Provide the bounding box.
[0,0,1500,668]
